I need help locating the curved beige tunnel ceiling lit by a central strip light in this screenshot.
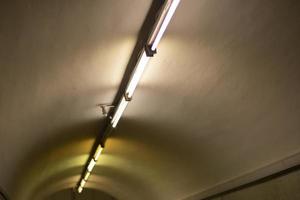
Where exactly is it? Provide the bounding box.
[0,0,300,199]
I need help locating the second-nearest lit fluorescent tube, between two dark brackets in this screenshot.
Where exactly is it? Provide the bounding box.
[126,50,150,98]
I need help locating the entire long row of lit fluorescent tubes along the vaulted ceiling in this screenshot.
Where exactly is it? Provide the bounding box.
[77,0,180,193]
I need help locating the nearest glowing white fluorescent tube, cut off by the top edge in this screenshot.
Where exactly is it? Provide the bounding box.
[151,0,180,51]
